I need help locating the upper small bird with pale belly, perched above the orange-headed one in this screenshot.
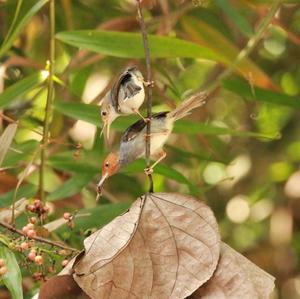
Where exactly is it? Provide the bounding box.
[100,67,149,140]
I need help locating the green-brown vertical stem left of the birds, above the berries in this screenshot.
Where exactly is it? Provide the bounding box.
[39,0,55,201]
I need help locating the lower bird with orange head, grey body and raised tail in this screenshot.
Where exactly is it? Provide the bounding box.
[97,92,207,194]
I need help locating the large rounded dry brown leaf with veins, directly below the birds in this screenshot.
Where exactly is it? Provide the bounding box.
[73,193,220,299]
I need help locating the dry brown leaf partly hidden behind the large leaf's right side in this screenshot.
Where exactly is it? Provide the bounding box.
[189,243,274,299]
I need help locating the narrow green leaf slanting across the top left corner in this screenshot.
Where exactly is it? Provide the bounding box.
[0,0,49,57]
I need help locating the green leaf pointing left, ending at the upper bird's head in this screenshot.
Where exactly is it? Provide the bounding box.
[54,101,101,127]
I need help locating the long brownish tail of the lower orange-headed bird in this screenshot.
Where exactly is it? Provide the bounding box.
[168,92,207,121]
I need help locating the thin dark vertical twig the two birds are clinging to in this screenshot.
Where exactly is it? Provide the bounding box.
[136,0,153,192]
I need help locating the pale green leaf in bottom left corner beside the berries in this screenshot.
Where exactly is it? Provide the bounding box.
[0,245,23,299]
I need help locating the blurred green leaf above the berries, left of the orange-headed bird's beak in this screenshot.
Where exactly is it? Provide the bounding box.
[47,172,95,201]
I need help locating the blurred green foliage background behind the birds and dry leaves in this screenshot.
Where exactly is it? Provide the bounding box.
[0,0,300,299]
